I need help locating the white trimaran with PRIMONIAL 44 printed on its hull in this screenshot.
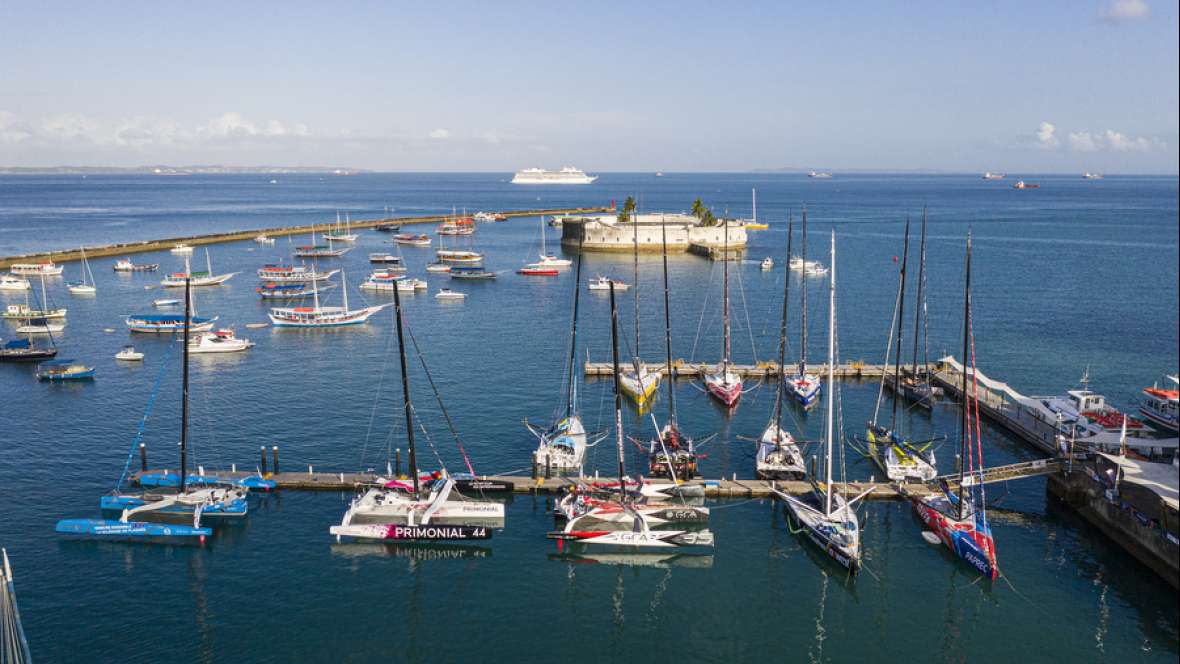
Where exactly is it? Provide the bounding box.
[328,290,504,541]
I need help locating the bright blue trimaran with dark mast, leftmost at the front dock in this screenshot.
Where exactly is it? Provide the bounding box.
[55,278,258,543]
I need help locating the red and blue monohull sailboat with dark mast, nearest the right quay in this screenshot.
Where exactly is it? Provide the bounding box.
[910,232,999,580]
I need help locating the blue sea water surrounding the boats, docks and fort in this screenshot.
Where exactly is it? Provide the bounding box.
[0,173,1180,662]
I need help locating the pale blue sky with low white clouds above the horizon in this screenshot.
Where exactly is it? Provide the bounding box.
[0,0,1180,173]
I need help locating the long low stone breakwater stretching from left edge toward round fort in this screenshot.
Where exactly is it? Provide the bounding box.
[0,208,610,269]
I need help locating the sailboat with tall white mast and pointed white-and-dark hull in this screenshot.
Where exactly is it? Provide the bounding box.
[772,230,873,573]
